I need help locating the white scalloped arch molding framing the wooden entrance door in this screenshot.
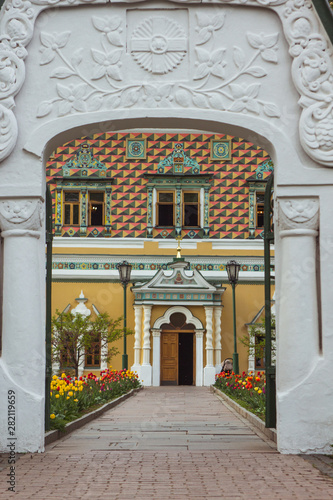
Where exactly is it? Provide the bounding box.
[152,306,205,386]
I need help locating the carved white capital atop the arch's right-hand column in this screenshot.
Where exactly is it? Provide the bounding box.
[279,198,319,231]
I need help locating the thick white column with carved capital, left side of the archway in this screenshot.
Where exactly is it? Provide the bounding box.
[0,198,45,452]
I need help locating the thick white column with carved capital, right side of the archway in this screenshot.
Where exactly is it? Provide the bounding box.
[276,197,320,453]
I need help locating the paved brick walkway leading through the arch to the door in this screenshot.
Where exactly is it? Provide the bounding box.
[0,386,333,500]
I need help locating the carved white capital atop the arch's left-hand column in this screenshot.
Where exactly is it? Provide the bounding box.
[0,198,43,231]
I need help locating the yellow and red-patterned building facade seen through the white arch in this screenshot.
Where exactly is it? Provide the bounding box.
[47,130,273,385]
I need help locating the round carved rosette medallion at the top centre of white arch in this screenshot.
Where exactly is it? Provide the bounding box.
[131,17,187,75]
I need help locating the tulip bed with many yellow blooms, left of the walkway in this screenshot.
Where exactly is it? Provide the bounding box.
[50,368,140,430]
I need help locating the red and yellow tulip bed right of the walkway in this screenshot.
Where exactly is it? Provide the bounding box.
[214,372,266,420]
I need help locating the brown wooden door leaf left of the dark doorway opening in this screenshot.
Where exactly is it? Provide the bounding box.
[161,332,178,385]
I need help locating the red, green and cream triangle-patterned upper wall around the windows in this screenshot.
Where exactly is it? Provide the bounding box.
[47,132,270,239]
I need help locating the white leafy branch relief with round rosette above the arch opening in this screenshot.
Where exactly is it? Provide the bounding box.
[37,12,280,118]
